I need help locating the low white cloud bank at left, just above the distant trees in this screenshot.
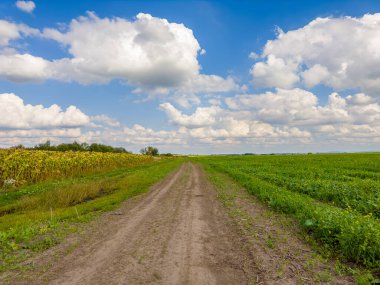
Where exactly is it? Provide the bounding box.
[0,93,186,147]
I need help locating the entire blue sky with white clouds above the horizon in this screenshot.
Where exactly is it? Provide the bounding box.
[0,0,380,153]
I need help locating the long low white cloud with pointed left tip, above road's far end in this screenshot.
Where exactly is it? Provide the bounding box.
[160,98,310,144]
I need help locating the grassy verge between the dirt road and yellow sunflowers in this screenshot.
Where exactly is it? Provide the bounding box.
[0,159,183,272]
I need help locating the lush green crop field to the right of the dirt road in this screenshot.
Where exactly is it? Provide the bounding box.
[193,153,380,271]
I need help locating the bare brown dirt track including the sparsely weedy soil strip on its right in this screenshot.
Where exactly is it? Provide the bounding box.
[7,163,353,285]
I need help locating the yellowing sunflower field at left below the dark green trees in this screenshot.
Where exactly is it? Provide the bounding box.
[0,149,153,187]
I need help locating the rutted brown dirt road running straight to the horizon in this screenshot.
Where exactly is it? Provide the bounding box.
[35,163,256,285]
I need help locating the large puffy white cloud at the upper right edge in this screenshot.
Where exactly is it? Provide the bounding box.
[251,13,380,95]
